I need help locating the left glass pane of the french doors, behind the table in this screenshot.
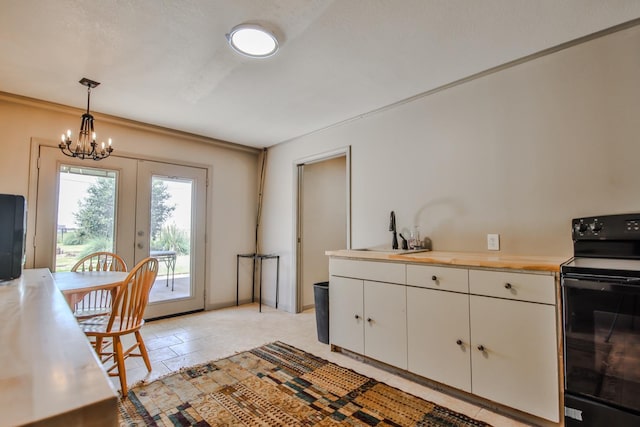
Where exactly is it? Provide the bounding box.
[55,164,118,271]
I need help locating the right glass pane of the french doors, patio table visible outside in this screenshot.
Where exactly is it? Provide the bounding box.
[149,175,193,302]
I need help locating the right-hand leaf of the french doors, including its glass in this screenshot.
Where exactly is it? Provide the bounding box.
[135,161,207,319]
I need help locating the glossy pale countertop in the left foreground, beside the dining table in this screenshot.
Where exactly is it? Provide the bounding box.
[0,268,118,427]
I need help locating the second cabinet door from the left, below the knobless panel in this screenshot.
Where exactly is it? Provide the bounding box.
[364,281,407,369]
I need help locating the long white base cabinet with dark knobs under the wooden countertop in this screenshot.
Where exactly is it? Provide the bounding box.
[329,259,560,422]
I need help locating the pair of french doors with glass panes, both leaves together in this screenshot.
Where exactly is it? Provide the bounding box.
[33,145,207,319]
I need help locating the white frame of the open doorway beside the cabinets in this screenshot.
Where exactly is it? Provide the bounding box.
[291,145,351,313]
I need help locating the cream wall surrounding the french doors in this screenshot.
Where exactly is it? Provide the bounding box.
[0,93,258,308]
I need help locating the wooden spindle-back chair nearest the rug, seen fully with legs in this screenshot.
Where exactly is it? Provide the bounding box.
[80,257,158,399]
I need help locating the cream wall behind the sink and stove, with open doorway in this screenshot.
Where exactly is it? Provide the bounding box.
[262,27,640,309]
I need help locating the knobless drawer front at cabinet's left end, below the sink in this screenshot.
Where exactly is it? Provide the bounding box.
[329,258,406,285]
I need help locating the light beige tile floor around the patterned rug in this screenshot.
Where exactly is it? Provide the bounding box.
[117,304,526,427]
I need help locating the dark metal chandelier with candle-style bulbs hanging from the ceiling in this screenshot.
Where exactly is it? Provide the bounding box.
[58,77,113,160]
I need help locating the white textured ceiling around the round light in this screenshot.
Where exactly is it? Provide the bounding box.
[0,0,640,147]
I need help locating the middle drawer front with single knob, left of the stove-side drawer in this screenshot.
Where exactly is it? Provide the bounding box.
[407,264,469,293]
